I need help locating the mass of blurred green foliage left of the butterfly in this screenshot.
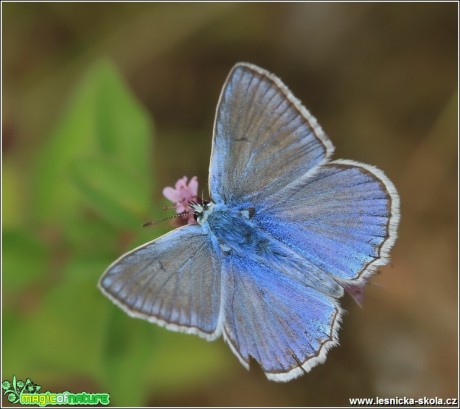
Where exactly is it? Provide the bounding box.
[2,62,232,406]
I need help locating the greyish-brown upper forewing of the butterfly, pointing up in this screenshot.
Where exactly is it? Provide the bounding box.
[209,63,334,203]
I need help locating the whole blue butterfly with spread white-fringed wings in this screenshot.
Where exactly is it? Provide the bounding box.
[99,63,399,382]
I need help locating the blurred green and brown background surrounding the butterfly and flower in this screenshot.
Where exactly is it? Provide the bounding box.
[2,2,458,406]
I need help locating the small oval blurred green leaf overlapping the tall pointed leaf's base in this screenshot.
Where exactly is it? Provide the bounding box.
[72,156,150,228]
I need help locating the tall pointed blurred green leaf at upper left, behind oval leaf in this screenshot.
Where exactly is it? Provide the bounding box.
[34,62,153,225]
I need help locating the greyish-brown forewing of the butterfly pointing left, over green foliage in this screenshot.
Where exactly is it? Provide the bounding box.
[99,225,221,339]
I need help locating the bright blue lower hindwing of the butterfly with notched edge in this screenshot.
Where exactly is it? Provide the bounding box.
[223,256,341,382]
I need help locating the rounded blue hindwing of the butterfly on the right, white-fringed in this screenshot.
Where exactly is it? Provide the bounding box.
[255,160,399,281]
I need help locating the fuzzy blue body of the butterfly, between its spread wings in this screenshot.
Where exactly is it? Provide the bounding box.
[198,203,343,298]
